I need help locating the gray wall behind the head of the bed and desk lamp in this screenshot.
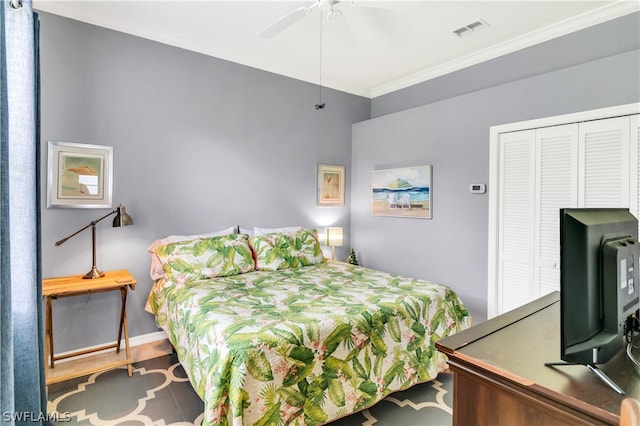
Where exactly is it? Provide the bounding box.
[40,13,370,352]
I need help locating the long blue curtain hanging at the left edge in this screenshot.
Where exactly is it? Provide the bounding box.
[0,0,50,425]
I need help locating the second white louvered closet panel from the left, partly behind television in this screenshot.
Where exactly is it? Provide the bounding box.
[533,124,578,299]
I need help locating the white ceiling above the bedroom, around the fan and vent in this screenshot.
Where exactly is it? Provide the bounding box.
[34,0,640,98]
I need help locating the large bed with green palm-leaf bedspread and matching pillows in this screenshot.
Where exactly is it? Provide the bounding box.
[146,229,470,425]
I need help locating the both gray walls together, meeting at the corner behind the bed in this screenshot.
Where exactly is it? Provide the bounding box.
[40,9,640,352]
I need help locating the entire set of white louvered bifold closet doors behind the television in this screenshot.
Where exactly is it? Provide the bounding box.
[496,115,640,314]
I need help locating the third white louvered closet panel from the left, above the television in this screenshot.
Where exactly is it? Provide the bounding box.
[578,117,631,207]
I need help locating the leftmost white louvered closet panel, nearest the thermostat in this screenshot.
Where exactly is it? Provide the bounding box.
[498,130,535,312]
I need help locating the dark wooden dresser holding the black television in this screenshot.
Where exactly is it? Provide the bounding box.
[436,292,640,426]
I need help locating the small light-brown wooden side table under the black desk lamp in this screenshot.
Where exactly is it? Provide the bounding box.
[42,270,136,384]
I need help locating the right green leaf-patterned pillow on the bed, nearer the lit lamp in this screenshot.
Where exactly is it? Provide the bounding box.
[249,229,324,271]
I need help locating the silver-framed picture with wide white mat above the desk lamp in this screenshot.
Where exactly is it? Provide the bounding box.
[47,141,113,209]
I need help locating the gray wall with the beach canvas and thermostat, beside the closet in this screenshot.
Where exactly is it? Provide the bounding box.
[351,14,640,323]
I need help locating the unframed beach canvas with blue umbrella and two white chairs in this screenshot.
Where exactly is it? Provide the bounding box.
[371,166,433,219]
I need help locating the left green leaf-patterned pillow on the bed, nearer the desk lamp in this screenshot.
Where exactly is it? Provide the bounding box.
[156,234,255,283]
